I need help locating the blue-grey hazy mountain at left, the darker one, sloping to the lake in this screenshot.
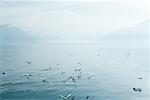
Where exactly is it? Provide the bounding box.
[0,24,35,44]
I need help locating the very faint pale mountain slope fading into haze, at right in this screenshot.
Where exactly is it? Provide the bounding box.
[98,21,149,48]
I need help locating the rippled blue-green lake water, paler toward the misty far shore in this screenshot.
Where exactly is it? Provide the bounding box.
[0,44,150,100]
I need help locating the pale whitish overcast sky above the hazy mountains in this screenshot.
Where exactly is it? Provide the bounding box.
[0,0,148,37]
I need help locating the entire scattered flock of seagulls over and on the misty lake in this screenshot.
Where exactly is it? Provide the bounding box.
[2,54,143,100]
